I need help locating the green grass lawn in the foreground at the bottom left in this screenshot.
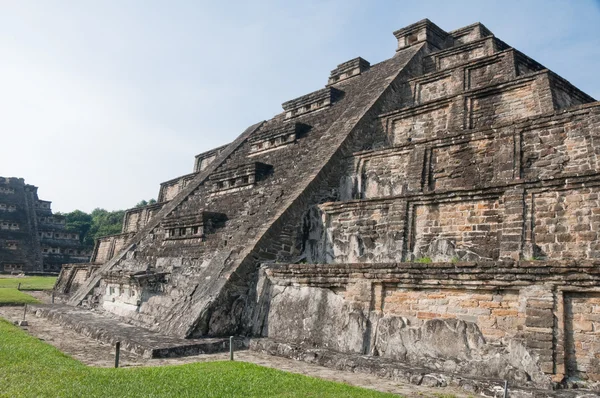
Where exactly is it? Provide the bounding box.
[0,319,395,397]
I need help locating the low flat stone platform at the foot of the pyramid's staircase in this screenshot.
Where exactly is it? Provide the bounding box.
[30,304,246,358]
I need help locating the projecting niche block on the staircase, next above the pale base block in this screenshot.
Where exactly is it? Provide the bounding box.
[161,211,227,241]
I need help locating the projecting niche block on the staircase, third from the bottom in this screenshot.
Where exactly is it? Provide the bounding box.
[209,162,273,194]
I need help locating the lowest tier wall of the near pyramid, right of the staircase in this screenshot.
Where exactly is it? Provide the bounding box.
[259,261,600,386]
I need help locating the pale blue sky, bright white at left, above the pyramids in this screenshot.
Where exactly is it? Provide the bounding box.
[0,0,600,211]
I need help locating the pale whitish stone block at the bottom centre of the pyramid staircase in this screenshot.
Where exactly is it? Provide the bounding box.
[102,270,169,316]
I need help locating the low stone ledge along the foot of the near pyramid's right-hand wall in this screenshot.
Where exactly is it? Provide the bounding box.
[249,338,600,398]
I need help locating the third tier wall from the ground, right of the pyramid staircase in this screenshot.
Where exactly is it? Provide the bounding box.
[352,105,600,199]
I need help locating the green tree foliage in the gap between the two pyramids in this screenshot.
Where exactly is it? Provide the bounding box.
[57,199,156,246]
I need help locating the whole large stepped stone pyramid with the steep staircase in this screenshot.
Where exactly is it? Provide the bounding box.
[52,20,600,389]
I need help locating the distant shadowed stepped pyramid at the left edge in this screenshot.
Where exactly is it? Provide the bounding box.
[0,177,91,272]
